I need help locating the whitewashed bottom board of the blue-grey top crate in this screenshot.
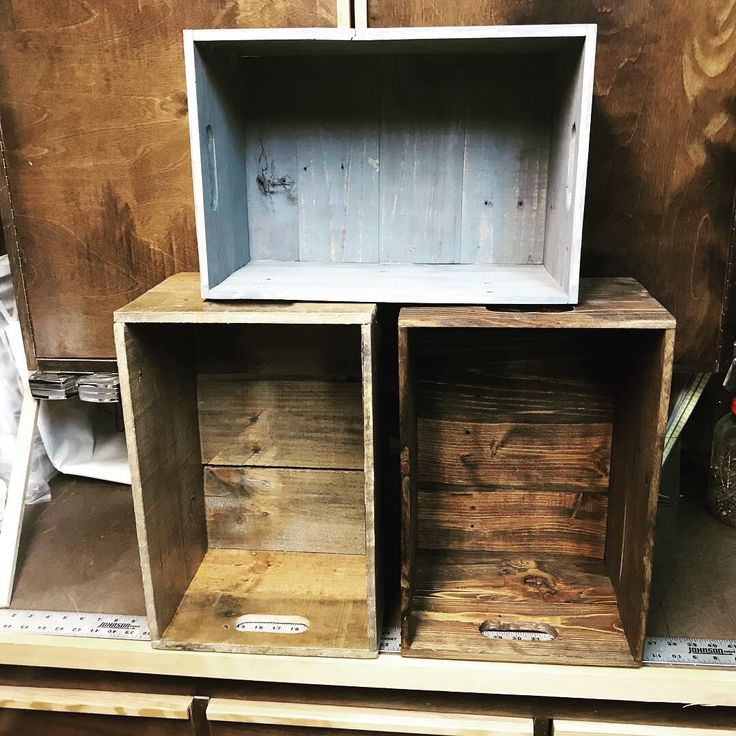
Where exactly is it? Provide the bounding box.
[207,261,569,304]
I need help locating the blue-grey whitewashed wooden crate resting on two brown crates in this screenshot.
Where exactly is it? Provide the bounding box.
[184,25,596,304]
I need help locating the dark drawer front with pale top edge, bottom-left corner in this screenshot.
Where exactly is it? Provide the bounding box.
[0,685,191,736]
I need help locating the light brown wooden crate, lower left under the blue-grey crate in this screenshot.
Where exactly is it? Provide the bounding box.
[115,274,378,657]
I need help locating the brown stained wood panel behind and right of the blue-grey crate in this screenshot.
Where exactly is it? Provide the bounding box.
[368,0,736,370]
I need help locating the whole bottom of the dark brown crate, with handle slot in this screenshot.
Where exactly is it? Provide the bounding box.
[402,552,639,667]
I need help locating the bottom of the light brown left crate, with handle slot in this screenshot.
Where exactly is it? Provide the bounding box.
[154,549,377,657]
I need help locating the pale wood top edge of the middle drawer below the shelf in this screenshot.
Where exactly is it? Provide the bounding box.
[207,698,534,736]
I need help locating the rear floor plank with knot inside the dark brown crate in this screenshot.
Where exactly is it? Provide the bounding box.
[415,550,616,611]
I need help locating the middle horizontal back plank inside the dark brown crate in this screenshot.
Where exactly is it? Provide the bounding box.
[415,417,611,493]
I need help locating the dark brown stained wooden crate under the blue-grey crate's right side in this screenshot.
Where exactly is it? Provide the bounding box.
[399,279,675,666]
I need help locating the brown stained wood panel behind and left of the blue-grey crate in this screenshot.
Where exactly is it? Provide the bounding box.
[0,0,336,358]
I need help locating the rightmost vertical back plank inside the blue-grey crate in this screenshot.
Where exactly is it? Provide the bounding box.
[459,54,553,263]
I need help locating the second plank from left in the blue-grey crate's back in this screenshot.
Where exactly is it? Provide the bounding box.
[296,57,380,263]
